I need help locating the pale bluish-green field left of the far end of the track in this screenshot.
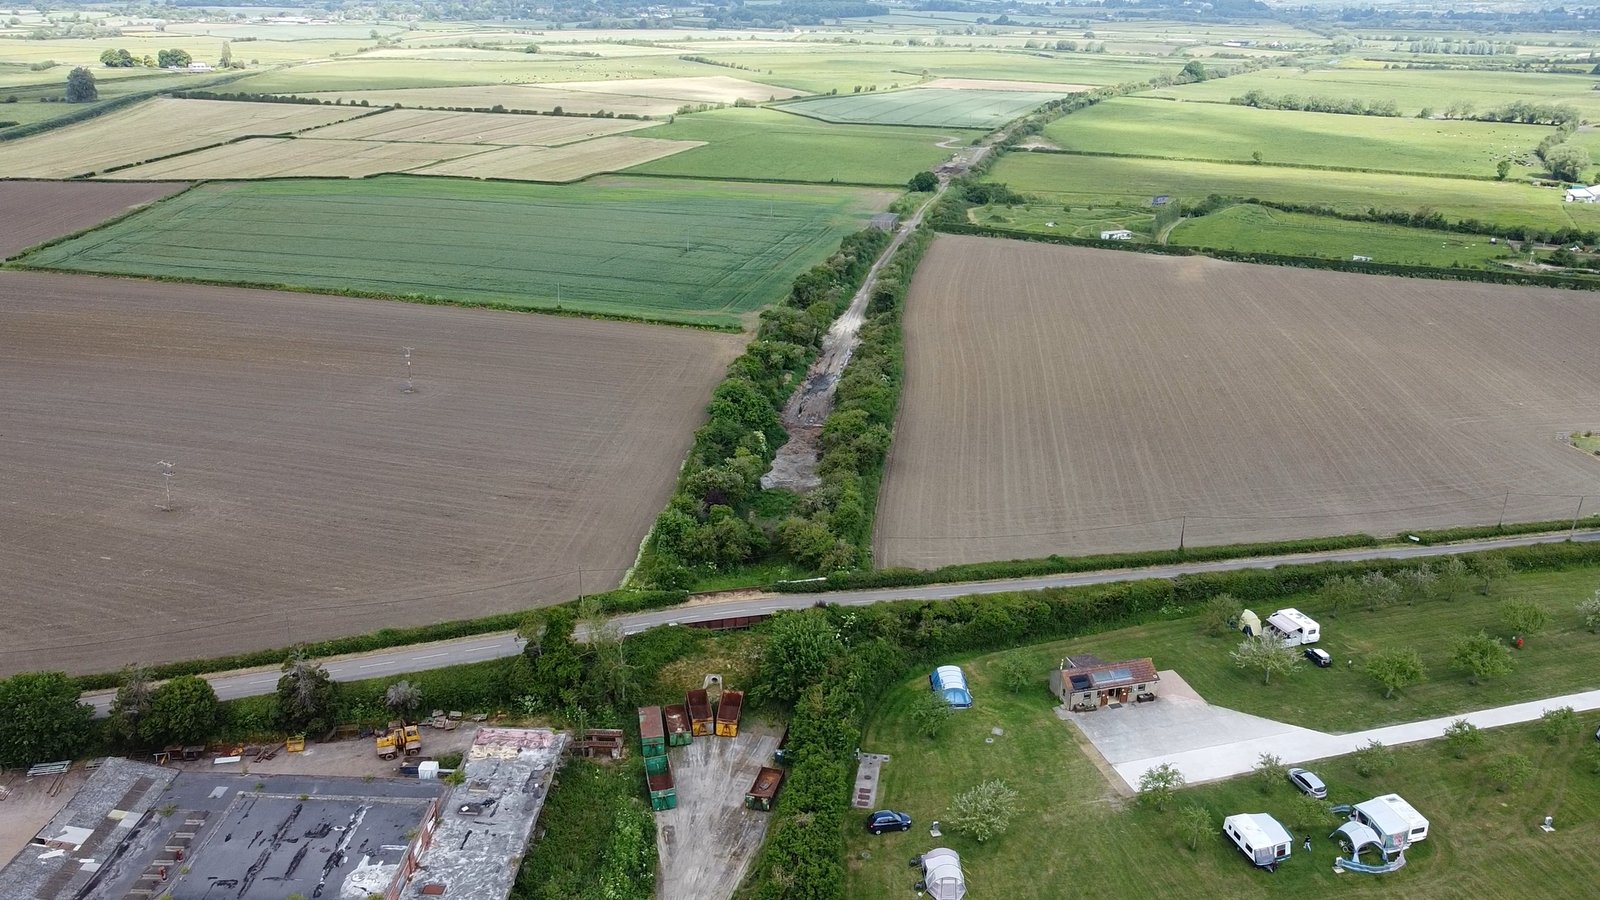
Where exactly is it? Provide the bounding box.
[779,88,1061,130]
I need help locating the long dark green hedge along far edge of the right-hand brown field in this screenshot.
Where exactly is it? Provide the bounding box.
[933,221,1600,290]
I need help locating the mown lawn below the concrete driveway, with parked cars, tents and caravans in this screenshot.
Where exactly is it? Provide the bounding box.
[845,630,1600,900]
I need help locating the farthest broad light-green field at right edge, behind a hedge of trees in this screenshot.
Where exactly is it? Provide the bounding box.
[1152,69,1600,119]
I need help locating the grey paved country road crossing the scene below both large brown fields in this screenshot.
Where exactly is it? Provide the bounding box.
[83,530,1600,714]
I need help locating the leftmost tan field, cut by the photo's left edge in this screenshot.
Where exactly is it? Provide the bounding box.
[0,98,370,178]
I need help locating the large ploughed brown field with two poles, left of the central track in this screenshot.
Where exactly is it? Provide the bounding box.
[0,272,742,674]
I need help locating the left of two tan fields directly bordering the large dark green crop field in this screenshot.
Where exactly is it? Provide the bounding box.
[102,138,486,181]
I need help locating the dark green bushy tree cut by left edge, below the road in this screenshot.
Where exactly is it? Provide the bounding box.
[0,673,94,769]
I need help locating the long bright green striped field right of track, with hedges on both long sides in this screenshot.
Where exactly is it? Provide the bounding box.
[1045,98,1555,178]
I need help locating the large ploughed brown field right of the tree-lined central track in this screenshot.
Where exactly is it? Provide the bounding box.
[875,235,1600,567]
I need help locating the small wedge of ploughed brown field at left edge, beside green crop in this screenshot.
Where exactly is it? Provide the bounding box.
[0,181,189,259]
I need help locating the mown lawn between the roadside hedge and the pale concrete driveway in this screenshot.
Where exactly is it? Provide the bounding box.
[1026,569,1600,733]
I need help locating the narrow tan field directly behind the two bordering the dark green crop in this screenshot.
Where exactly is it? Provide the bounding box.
[306,109,653,147]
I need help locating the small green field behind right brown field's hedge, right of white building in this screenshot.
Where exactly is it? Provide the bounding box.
[1168,203,1514,267]
